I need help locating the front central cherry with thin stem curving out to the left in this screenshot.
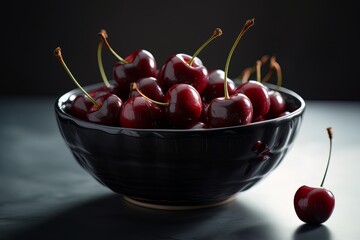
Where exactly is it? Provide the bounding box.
[132,83,202,128]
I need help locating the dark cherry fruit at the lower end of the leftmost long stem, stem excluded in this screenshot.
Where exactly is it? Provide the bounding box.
[86,94,123,126]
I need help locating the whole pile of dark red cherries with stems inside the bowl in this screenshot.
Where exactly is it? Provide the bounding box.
[54,19,288,129]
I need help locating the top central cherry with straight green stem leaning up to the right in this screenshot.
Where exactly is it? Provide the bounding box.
[159,28,222,94]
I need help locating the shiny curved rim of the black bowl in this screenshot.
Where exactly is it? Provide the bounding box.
[55,81,306,133]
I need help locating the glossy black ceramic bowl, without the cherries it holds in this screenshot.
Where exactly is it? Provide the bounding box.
[55,81,305,209]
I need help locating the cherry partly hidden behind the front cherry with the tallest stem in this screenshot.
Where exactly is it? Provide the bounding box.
[235,80,270,118]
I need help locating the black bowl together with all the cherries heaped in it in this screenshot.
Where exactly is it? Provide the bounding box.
[54,19,305,209]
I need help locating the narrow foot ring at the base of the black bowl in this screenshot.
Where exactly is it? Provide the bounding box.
[124,195,236,210]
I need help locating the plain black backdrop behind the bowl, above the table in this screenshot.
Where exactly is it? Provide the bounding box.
[0,0,360,100]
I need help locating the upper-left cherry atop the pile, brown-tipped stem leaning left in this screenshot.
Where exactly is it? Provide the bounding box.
[99,31,157,99]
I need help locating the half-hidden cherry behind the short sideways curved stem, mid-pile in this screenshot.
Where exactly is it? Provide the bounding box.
[129,77,165,102]
